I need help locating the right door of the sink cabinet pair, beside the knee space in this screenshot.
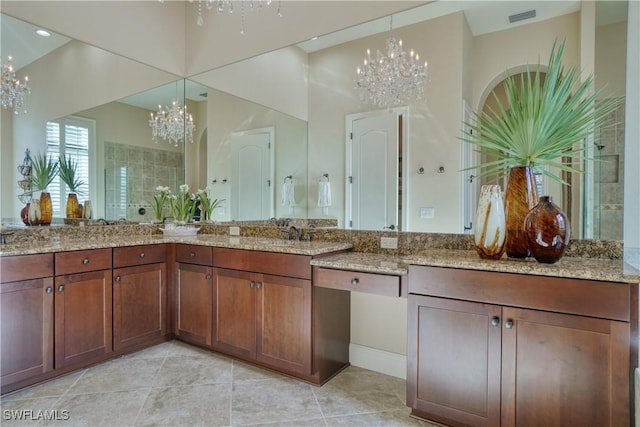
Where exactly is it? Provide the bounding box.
[256,275,311,375]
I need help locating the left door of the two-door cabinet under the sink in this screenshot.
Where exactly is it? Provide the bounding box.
[213,268,257,359]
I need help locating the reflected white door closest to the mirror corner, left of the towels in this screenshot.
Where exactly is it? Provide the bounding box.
[230,132,273,221]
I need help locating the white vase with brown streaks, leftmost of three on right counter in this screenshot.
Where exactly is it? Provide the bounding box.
[474,185,507,259]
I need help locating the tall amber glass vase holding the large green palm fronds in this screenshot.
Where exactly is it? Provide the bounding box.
[504,166,538,258]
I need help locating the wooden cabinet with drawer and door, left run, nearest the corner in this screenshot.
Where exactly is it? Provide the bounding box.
[113,244,167,351]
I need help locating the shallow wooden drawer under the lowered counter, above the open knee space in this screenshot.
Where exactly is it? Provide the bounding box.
[313,267,400,297]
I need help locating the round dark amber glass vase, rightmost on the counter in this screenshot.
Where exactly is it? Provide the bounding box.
[524,196,571,264]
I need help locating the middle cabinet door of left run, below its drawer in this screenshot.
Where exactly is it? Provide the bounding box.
[55,270,113,368]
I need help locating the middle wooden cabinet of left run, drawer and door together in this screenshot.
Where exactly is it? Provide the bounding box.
[54,249,113,369]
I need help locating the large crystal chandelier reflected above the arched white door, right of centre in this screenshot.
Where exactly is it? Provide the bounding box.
[355,17,427,107]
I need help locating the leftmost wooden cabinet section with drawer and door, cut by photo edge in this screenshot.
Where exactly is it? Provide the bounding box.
[0,254,54,393]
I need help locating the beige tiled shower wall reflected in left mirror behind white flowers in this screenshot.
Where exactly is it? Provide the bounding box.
[104,142,184,221]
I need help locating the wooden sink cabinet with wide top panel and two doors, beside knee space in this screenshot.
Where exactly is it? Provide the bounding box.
[213,248,312,377]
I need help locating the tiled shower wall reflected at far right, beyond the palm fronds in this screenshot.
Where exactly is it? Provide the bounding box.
[593,100,624,240]
